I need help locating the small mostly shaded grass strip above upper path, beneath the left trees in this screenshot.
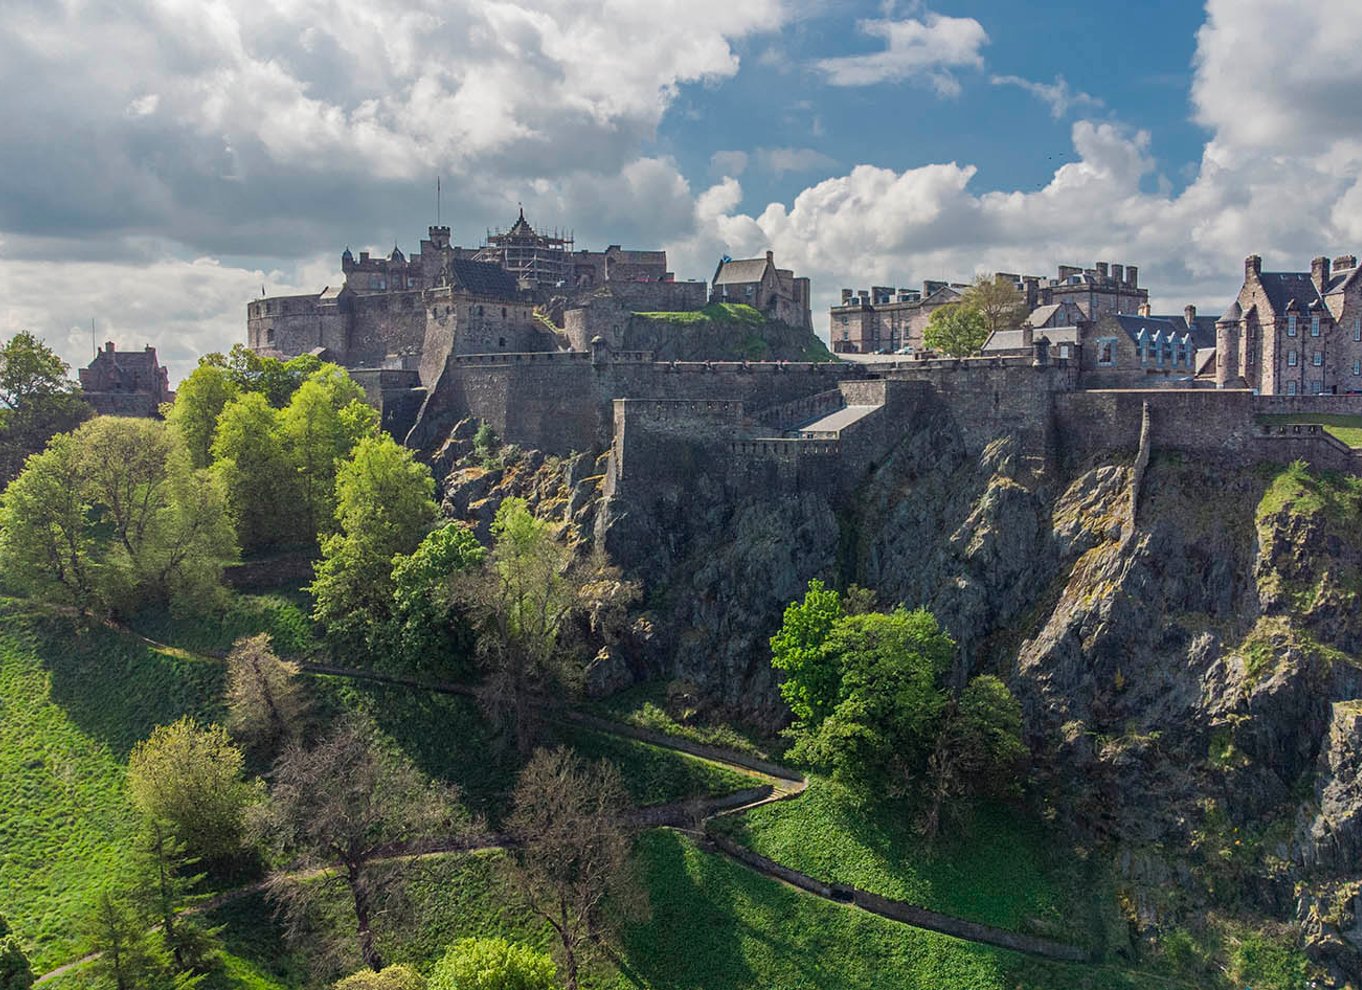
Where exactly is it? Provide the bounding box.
[129,591,317,655]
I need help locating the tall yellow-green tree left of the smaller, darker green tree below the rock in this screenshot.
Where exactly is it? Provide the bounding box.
[312,434,437,648]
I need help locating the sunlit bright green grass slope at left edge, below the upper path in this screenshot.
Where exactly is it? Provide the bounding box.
[0,601,222,971]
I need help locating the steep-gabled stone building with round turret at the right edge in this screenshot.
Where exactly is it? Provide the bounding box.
[1215,255,1362,395]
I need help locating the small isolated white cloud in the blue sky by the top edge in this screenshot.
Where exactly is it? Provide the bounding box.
[814,11,989,97]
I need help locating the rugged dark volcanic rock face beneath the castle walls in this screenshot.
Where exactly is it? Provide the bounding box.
[433,407,1362,979]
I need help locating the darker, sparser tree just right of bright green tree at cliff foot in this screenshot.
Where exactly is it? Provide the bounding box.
[922,674,1027,837]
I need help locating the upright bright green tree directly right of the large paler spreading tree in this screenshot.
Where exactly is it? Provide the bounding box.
[212,392,308,553]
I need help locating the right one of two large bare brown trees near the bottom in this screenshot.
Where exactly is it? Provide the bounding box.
[507,748,647,990]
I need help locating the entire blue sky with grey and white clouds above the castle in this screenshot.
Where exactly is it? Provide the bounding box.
[0,0,1362,376]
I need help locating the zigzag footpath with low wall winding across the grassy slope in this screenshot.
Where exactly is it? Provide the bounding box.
[34,626,1100,986]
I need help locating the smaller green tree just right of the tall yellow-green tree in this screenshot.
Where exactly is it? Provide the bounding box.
[392,523,486,669]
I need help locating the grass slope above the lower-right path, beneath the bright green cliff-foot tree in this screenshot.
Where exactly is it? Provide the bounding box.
[720,778,1102,945]
